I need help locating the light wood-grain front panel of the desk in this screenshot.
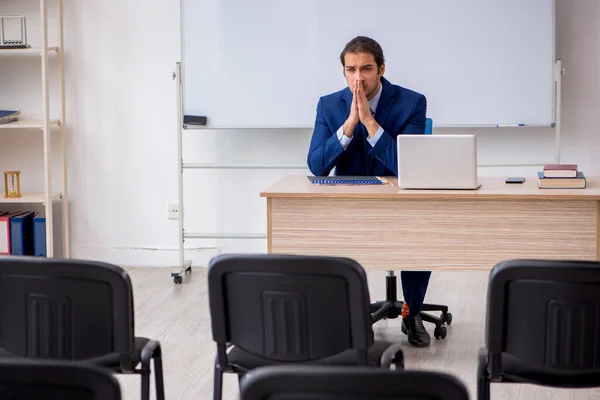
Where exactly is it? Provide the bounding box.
[270,198,600,270]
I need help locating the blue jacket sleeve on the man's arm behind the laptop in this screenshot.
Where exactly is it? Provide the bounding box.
[369,95,427,176]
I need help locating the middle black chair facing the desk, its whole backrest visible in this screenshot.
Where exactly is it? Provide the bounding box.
[208,254,403,400]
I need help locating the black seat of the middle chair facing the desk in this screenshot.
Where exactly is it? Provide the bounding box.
[227,340,392,370]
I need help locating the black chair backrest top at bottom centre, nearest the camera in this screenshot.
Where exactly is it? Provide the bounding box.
[240,365,469,400]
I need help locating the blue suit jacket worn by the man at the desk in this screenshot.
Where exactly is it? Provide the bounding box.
[307,77,427,176]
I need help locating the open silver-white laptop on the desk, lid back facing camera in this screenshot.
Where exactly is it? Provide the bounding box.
[396,135,480,190]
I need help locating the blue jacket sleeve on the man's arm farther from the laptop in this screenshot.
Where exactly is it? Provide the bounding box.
[307,99,344,176]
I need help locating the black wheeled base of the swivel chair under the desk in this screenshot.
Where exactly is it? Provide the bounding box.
[371,271,452,339]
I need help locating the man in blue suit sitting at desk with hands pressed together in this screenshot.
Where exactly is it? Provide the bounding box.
[308,36,431,347]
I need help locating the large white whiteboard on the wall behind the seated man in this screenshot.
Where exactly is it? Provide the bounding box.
[181,0,555,128]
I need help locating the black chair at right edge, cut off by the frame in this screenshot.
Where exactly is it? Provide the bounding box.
[477,260,600,400]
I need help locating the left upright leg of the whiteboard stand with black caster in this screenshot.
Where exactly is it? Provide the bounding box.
[171,62,192,284]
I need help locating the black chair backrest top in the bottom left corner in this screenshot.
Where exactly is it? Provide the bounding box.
[0,358,121,400]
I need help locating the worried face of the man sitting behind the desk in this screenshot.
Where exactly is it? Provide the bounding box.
[344,53,385,100]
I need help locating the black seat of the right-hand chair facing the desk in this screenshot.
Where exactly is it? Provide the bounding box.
[502,354,600,387]
